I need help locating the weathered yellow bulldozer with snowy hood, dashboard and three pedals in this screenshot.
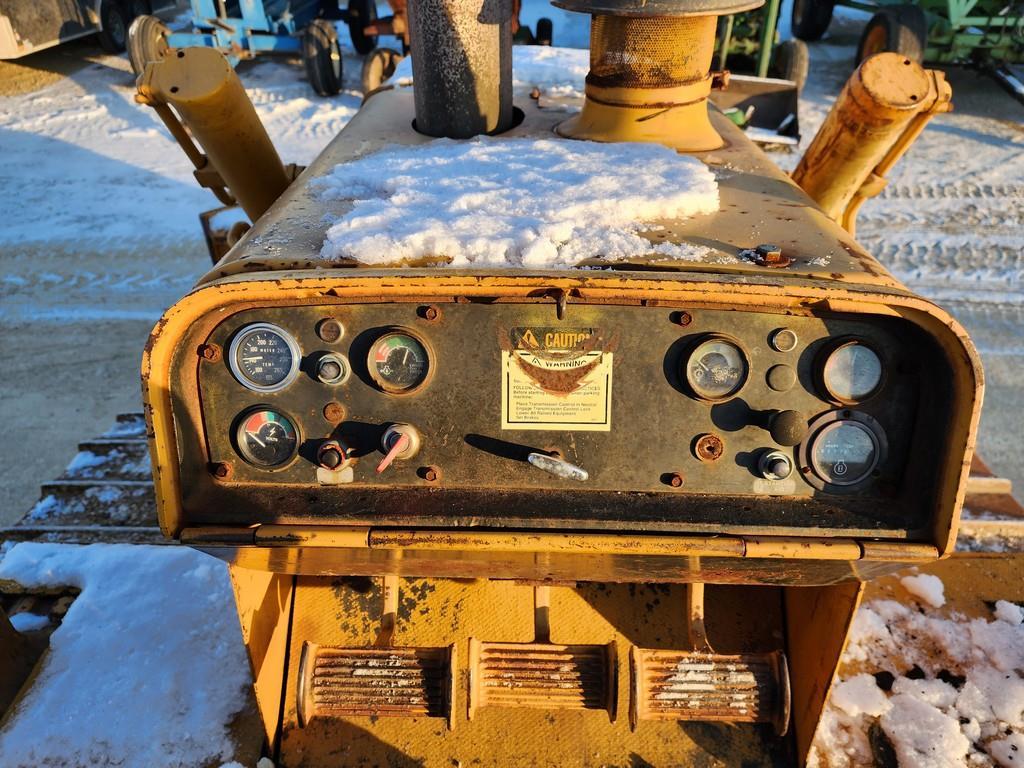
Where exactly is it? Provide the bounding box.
[4,0,1019,766]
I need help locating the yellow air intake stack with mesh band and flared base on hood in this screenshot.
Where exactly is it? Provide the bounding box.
[552,0,764,152]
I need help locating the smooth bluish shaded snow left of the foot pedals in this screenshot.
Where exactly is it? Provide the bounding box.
[0,544,251,768]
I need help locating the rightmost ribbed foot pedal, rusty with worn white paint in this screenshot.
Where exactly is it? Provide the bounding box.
[632,648,790,731]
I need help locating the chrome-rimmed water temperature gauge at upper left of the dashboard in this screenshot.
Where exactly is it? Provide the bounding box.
[227,323,300,392]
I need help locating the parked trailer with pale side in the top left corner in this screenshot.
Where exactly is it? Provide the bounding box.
[0,0,174,59]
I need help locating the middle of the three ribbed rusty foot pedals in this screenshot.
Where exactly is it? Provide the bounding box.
[469,640,615,721]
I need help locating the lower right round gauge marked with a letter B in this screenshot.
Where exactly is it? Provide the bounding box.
[800,411,887,489]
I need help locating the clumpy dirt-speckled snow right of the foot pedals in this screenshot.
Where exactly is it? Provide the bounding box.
[808,575,1024,768]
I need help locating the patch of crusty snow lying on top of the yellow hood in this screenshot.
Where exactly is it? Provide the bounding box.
[316,137,718,268]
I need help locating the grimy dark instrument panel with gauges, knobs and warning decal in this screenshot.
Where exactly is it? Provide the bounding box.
[179,302,951,538]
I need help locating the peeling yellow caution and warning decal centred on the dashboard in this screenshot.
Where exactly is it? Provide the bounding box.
[500,327,613,432]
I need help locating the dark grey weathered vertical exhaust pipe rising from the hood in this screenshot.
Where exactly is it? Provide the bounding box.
[409,0,513,138]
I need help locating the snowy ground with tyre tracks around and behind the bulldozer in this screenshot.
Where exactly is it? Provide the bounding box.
[0,18,1024,524]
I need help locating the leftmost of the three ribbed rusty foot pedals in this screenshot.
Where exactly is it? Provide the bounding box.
[298,643,453,723]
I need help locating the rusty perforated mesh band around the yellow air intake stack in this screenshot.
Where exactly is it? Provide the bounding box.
[587,15,715,88]
